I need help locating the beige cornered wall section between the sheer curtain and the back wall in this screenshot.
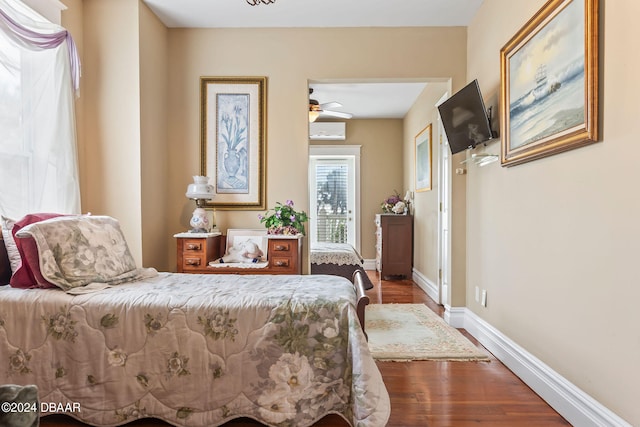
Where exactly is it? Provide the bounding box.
[62,0,170,269]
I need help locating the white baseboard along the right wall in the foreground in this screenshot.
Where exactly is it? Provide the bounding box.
[460,307,631,427]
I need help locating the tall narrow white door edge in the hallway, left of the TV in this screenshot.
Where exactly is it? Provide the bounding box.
[438,94,451,305]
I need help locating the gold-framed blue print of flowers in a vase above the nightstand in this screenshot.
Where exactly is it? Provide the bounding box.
[200,77,267,210]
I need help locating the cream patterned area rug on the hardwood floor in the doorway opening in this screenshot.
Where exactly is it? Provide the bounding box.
[365,304,489,361]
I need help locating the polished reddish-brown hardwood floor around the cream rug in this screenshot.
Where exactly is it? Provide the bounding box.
[40,272,570,427]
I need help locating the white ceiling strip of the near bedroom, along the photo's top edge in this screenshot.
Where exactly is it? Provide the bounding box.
[144,0,483,28]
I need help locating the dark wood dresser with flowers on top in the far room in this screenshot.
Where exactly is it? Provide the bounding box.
[376,214,413,278]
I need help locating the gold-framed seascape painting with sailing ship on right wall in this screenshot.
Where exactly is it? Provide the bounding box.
[500,0,599,166]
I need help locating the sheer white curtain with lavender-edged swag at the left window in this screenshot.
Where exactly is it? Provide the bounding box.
[0,0,80,218]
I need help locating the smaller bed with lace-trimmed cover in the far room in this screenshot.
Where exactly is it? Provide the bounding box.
[309,242,373,290]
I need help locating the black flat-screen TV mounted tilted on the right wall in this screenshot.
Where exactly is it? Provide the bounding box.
[438,80,495,154]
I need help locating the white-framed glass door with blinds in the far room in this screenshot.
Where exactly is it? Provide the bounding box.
[309,146,360,250]
